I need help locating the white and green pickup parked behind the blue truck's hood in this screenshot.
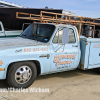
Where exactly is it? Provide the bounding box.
[0,21,23,38]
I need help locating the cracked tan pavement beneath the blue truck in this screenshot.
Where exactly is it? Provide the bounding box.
[0,69,100,100]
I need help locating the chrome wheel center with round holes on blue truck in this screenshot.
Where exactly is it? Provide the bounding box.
[15,66,32,84]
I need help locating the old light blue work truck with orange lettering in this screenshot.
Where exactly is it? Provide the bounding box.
[0,23,100,88]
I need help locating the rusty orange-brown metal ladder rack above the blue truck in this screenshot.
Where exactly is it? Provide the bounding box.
[16,11,100,38]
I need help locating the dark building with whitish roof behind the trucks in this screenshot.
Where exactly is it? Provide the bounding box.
[0,0,76,29]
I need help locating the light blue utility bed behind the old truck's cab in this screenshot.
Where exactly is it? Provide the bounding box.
[80,37,100,70]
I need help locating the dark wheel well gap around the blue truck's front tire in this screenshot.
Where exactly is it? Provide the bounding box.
[6,60,41,76]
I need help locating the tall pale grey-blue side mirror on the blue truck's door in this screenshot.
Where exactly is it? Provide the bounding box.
[62,28,69,44]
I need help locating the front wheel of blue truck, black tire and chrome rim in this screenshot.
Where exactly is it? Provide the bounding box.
[7,62,37,88]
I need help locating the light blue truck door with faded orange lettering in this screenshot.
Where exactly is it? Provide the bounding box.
[50,27,79,72]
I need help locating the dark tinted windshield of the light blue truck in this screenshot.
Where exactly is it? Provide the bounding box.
[20,24,55,42]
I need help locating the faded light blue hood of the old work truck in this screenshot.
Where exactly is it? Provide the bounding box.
[0,37,42,50]
